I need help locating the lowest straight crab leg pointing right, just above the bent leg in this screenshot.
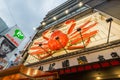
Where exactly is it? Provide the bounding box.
[70,30,98,45]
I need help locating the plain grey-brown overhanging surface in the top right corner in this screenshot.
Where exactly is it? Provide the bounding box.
[95,0,120,20]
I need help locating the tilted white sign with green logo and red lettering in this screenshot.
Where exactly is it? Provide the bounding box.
[5,26,25,47]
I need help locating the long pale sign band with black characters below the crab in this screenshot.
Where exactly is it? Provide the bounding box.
[28,47,120,71]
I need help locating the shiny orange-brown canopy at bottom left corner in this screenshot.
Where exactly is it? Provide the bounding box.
[0,65,58,80]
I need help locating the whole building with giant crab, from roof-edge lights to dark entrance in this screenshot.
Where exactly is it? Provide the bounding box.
[23,0,120,80]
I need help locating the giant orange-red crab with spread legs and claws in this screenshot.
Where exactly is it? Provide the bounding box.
[29,18,98,58]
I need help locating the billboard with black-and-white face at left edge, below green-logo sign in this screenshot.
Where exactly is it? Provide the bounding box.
[0,37,16,70]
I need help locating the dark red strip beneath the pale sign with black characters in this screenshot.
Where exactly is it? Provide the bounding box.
[57,58,120,75]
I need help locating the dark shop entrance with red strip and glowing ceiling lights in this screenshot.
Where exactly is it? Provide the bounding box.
[53,58,120,80]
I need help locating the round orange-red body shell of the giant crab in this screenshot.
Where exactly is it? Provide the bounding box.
[48,30,69,50]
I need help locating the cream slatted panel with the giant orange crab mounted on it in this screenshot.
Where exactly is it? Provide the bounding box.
[28,13,120,62]
